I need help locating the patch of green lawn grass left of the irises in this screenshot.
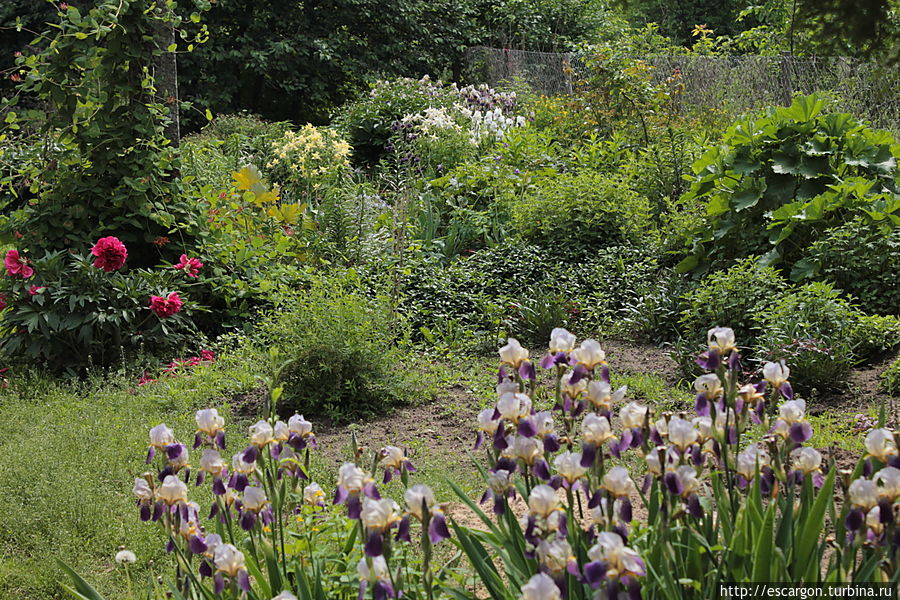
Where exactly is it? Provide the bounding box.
[0,358,255,600]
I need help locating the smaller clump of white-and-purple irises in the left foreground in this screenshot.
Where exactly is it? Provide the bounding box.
[133,396,450,600]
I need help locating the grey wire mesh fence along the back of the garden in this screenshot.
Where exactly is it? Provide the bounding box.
[468,46,900,131]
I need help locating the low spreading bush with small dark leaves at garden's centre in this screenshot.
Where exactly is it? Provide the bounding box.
[400,242,657,350]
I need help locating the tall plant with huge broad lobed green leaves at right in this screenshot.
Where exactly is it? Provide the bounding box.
[679,96,900,279]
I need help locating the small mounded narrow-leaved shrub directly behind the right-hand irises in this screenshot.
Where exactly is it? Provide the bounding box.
[754,282,859,394]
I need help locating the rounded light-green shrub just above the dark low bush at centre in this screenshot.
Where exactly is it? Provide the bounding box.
[509,171,658,255]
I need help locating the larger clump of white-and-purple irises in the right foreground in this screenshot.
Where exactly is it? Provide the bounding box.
[470,327,900,600]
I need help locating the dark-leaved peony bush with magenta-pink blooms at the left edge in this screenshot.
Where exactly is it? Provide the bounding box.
[0,239,201,372]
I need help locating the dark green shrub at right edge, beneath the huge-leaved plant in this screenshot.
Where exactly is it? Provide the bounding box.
[806,217,900,314]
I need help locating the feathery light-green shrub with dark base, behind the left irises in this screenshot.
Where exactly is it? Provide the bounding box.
[256,274,425,420]
